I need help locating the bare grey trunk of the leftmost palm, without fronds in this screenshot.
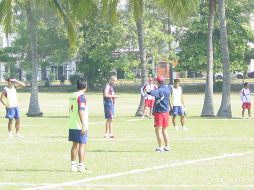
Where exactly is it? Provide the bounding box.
[26,0,42,116]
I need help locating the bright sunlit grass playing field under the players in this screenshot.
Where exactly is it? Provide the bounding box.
[0,93,254,190]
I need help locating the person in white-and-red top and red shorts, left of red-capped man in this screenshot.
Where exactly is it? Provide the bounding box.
[140,76,157,119]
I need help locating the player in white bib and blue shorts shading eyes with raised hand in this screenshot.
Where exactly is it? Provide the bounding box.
[0,78,26,138]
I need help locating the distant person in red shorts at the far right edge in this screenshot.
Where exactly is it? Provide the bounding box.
[240,82,251,118]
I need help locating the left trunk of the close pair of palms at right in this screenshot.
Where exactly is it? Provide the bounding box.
[201,0,215,117]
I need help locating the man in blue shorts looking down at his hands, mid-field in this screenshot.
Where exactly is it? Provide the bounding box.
[103,75,117,138]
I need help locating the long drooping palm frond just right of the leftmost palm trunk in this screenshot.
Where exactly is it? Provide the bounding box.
[54,0,76,46]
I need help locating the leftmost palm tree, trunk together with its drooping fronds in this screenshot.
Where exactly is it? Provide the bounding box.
[0,0,75,116]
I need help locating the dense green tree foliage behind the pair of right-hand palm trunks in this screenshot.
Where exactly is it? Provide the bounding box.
[177,0,254,72]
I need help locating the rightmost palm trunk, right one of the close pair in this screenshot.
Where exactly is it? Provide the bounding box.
[217,0,232,118]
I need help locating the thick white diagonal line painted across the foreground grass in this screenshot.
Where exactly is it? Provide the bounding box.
[26,151,254,190]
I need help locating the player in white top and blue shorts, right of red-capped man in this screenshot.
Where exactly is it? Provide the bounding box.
[170,79,189,131]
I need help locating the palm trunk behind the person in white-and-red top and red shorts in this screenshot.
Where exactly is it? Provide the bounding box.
[135,18,147,117]
